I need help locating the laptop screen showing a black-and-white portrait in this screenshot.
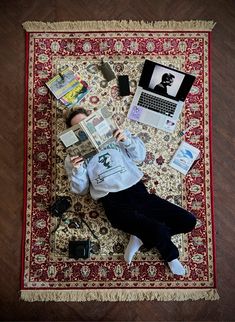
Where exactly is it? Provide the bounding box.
[139,59,195,101]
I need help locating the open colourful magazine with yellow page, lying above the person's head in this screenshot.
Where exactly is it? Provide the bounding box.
[46,68,90,108]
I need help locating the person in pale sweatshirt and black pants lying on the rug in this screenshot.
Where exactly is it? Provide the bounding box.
[65,109,196,275]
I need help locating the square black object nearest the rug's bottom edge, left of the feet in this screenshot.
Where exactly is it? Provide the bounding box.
[69,239,90,259]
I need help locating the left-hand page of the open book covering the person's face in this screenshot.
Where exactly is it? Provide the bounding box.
[59,124,97,159]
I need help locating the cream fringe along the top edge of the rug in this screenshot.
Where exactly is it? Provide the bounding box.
[22,20,216,32]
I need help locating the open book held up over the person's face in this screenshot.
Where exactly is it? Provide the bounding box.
[58,107,117,159]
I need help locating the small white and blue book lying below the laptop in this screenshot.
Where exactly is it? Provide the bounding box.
[169,141,200,175]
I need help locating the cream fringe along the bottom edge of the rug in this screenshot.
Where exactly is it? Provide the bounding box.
[21,289,219,302]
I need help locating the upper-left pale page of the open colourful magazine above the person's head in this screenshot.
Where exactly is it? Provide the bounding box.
[46,68,79,99]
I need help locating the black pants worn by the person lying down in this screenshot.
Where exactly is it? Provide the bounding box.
[100,181,196,262]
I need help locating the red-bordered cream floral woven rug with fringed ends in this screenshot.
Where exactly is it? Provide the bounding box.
[21,21,218,301]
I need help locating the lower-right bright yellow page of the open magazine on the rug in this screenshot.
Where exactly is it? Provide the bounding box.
[60,75,90,108]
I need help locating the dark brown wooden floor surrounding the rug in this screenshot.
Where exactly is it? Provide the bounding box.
[0,0,235,321]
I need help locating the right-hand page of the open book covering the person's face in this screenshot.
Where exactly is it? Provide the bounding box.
[80,107,117,150]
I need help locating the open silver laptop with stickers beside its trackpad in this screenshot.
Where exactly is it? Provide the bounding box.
[127,59,195,132]
